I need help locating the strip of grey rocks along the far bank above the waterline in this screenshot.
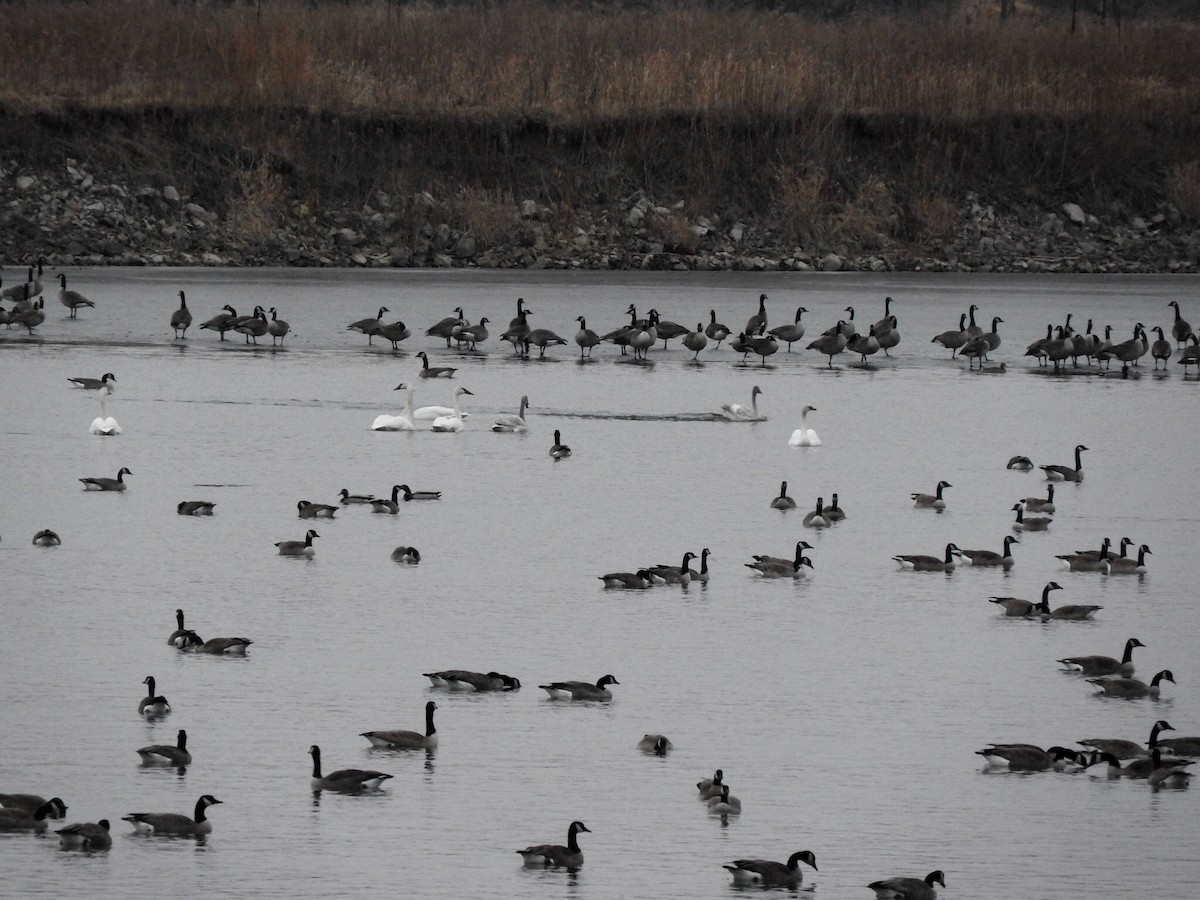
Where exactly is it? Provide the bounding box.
[0,160,1200,274]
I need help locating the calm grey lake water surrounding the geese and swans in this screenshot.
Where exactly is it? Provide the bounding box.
[0,269,1200,899]
